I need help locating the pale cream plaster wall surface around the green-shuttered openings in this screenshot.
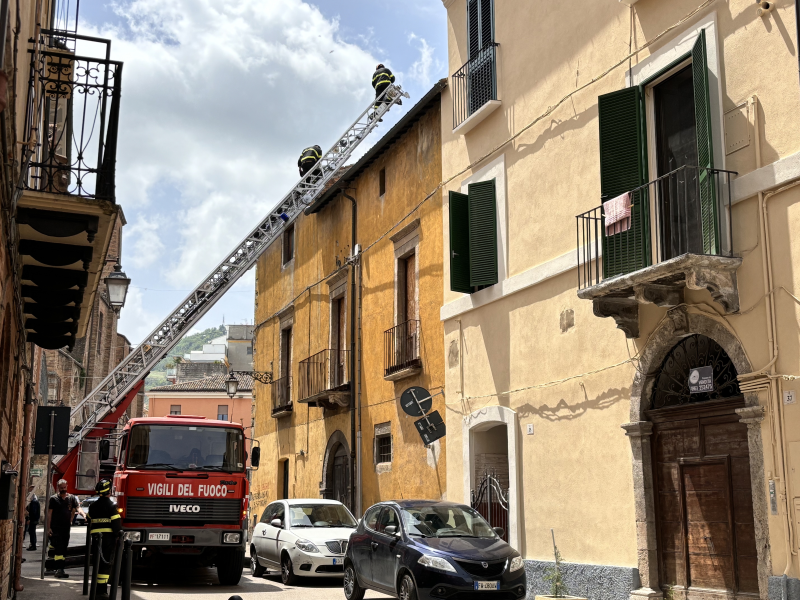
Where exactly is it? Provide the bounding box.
[441,0,800,588]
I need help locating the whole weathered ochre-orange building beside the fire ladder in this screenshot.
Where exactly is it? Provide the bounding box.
[251,80,446,518]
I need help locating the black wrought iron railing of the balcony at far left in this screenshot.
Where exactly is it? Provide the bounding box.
[25,30,122,202]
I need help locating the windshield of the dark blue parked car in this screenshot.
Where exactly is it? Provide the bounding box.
[400,504,497,538]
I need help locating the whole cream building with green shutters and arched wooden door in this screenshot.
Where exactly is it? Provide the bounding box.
[437,0,800,599]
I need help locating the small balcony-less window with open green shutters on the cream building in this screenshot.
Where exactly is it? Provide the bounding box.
[449,179,498,294]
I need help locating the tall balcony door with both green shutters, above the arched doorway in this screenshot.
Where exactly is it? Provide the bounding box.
[598,30,720,278]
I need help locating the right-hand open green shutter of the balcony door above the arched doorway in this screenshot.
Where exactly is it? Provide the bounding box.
[692,30,719,254]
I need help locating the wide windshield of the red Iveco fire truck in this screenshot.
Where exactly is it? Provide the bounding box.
[127,425,244,472]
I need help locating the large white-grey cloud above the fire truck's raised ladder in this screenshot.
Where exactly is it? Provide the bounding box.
[84,0,376,290]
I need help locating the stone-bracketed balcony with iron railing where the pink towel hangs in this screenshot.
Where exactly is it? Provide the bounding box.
[576,166,742,338]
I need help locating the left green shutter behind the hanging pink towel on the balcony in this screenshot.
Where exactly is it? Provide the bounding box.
[597,87,650,278]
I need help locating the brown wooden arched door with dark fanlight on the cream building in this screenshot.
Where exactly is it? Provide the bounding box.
[644,334,759,599]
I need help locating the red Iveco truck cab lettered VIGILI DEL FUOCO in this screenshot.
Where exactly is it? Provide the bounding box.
[113,415,258,585]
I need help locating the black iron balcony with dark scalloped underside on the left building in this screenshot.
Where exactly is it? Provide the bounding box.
[17,30,122,349]
